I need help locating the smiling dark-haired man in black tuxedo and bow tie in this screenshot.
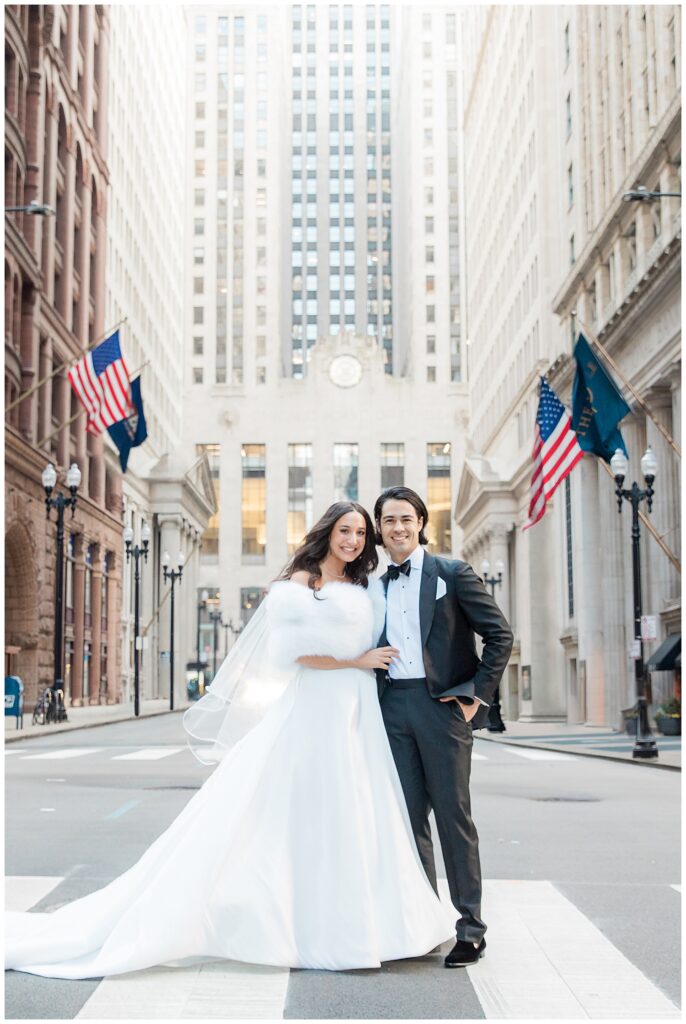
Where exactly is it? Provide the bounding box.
[374,486,512,967]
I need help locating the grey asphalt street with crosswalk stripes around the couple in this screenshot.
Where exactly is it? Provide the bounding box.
[5,714,681,1019]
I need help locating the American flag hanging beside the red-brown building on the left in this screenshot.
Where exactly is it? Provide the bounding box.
[67,331,135,434]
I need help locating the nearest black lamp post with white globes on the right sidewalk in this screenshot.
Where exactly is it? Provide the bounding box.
[610,447,658,758]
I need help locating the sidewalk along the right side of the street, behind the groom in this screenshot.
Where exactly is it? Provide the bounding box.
[474,721,681,771]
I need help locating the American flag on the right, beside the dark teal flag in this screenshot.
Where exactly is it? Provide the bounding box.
[522,377,584,529]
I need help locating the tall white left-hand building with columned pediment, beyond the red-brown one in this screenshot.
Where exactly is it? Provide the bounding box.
[105,5,213,706]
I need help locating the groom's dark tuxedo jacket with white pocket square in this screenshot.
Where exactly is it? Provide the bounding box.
[377,550,513,729]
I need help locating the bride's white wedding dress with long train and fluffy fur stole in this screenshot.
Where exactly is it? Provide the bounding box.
[5,581,456,978]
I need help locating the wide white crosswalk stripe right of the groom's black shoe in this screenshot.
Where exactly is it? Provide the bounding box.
[438,879,681,1020]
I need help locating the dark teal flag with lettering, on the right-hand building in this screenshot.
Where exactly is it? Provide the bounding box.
[571,334,631,463]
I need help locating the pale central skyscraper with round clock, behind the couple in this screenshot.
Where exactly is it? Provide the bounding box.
[184,4,466,652]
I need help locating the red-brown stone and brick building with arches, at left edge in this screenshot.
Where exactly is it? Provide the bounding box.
[4,4,122,707]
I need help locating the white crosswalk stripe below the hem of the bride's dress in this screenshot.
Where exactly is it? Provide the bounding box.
[77,961,290,1020]
